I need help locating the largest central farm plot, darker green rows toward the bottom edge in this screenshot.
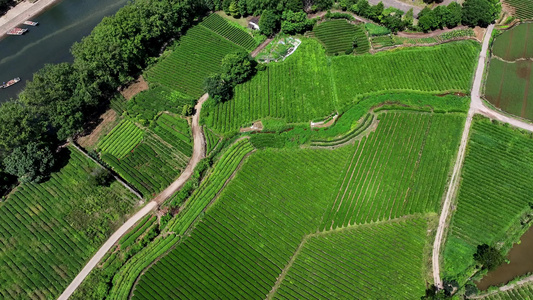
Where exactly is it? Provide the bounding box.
[133,148,350,299]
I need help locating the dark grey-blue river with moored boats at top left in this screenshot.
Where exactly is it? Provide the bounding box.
[0,0,128,103]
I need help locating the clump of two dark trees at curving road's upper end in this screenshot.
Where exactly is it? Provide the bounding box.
[204,51,257,104]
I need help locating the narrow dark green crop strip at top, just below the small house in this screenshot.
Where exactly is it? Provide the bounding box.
[201,14,257,51]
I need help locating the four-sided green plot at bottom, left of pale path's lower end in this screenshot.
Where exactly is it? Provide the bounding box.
[273,218,429,299]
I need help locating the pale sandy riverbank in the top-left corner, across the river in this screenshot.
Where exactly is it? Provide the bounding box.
[0,0,60,39]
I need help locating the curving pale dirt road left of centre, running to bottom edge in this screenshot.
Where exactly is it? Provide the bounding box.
[58,94,209,300]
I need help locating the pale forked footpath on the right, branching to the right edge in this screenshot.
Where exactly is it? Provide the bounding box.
[432,25,533,288]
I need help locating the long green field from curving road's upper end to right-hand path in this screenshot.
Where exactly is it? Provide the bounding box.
[202,38,479,133]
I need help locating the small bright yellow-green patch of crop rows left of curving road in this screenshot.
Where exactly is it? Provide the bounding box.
[98,120,143,159]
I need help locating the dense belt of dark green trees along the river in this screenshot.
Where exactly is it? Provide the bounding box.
[0,0,204,182]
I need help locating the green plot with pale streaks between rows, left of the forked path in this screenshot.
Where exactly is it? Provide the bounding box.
[320,112,464,230]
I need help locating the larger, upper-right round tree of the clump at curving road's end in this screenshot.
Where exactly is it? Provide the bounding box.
[222,51,255,86]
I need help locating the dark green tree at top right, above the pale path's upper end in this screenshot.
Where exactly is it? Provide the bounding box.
[462,0,501,27]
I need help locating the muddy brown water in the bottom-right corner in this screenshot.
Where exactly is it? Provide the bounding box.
[476,227,533,290]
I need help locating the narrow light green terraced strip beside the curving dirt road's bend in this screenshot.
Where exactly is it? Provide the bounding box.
[171,139,253,235]
